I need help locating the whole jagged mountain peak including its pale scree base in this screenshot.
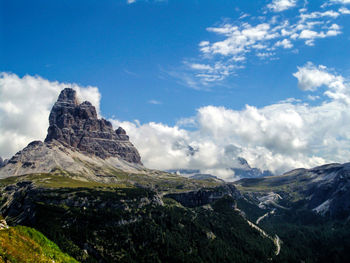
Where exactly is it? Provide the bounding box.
[0,88,144,181]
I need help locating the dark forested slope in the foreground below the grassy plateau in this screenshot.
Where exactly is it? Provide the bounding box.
[2,177,275,262]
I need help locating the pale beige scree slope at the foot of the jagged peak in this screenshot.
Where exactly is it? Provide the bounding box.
[0,140,148,179]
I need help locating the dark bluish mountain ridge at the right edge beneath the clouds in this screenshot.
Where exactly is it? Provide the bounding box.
[236,163,350,220]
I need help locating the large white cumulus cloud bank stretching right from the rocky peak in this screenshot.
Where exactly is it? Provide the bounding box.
[113,63,350,180]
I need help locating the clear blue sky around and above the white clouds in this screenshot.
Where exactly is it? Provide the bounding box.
[0,0,350,124]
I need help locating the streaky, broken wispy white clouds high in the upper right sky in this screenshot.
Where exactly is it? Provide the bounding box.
[178,0,350,89]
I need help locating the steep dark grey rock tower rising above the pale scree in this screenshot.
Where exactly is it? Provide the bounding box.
[45,88,141,164]
